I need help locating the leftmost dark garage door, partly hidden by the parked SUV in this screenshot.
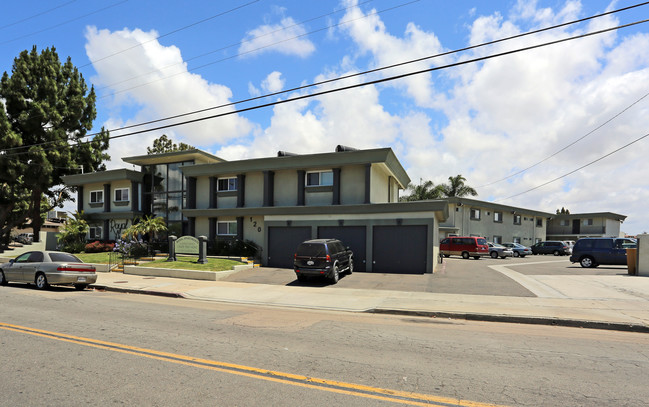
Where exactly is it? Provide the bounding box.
[267,226,311,268]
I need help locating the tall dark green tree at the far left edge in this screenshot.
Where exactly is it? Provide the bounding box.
[0,46,110,241]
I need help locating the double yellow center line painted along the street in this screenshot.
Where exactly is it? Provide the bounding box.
[0,322,500,407]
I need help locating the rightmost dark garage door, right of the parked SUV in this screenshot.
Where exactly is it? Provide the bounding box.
[372,225,428,274]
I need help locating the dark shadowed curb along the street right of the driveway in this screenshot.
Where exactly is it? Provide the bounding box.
[364,308,649,333]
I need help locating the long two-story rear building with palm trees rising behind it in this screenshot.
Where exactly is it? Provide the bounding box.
[439,198,554,246]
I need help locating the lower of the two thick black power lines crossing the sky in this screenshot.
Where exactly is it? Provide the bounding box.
[4,14,649,157]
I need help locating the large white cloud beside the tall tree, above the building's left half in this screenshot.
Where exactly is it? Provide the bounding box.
[86,27,254,154]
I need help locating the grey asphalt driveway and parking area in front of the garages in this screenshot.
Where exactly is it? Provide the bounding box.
[222,255,627,297]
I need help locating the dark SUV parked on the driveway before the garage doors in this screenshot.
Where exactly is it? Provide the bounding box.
[293,239,354,284]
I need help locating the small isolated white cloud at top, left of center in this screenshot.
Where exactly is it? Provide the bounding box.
[239,17,315,58]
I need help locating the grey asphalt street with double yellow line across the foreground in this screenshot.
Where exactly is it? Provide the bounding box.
[0,285,649,406]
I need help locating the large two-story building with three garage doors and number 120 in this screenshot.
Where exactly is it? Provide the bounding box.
[65,146,448,273]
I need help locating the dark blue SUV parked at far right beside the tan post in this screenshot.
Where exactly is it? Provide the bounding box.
[570,237,638,268]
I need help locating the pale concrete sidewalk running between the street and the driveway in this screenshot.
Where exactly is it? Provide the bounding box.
[93,273,649,333]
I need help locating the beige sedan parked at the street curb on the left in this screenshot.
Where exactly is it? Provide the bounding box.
[0,251,97,290]
